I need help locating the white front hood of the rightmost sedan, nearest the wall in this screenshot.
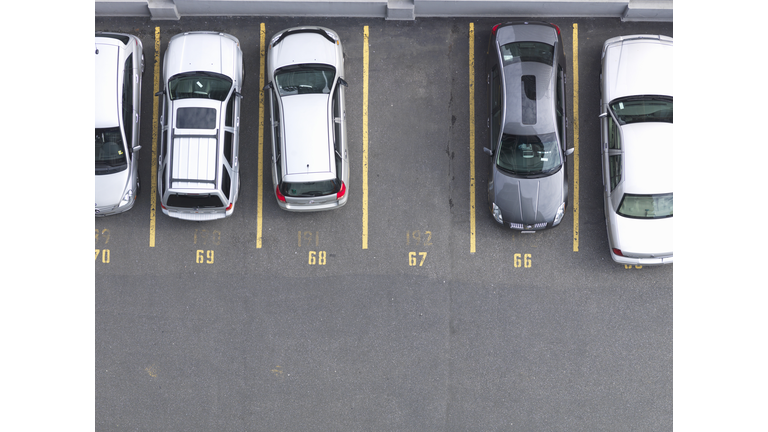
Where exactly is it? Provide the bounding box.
[603,35,673,102]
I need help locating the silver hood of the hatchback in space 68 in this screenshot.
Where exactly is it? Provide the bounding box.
[270,27,338,70]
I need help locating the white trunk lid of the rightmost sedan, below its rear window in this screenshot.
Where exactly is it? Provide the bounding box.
[611,216,673,256]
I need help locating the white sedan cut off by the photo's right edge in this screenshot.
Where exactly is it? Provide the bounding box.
[600,35,673,265]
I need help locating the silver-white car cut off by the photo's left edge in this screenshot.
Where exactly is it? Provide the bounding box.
[95,32,144,216]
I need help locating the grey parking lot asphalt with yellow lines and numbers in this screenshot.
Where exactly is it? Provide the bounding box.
[95,17,673,431]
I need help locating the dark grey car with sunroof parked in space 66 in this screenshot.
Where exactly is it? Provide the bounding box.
[484,21,573,232]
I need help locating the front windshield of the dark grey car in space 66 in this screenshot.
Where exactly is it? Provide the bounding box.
[496,132,561,176]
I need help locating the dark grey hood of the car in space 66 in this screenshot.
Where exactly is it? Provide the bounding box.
[493,167,565,224]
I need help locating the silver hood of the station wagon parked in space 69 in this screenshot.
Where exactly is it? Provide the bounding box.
[164,32,238,80]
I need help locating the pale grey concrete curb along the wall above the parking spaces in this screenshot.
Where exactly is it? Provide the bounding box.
[95,0,673,22]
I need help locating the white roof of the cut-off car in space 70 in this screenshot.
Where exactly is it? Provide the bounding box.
[95,41,123,128]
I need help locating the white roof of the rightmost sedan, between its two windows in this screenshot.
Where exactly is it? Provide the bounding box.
[621,122,674,194]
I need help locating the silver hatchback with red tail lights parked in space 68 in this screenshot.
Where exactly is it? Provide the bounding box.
[265,27,349,211]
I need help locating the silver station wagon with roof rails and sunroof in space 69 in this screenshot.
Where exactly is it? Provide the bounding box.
[156,32,243,221]
